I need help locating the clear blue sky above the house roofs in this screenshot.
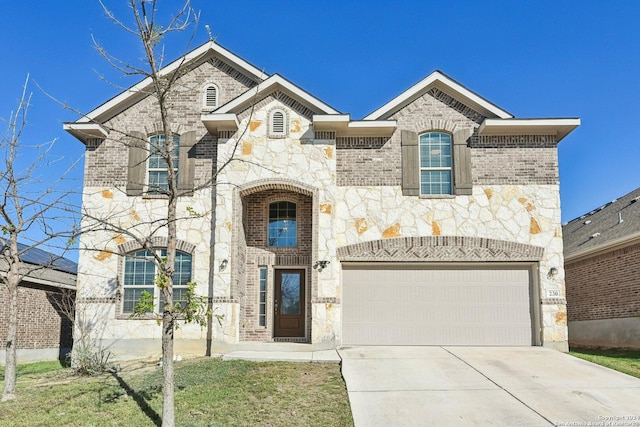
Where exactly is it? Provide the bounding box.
[0,0,640,241]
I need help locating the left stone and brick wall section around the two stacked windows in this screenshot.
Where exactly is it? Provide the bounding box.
[76,59,257,358]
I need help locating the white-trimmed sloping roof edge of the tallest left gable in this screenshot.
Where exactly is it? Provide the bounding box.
[70,41,268,125]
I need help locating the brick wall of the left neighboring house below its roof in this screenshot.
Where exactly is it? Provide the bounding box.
[0,282,75,364]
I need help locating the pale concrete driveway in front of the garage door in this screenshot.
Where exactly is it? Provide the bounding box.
[338,347,640,427]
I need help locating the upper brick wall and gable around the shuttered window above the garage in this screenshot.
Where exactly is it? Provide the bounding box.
[336,90,559,186]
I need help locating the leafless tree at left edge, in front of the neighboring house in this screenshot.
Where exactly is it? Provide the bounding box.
[0,77,75,401]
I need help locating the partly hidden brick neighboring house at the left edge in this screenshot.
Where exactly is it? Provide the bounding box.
[0,244,78,365]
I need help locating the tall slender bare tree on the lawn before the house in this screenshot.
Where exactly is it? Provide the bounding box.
[66,0,249,426]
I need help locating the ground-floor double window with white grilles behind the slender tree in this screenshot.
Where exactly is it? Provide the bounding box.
[122,249,192,313]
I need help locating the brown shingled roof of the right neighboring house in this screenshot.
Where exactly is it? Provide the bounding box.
[562,188,640,260]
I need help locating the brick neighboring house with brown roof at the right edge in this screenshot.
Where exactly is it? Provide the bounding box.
[562,188,640,348]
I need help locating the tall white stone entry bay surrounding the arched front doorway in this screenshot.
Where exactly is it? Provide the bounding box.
[214,96,340,344]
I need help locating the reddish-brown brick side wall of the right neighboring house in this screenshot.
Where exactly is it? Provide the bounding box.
[565,243,640,321]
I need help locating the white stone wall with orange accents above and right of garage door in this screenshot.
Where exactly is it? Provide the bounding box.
[335,185,567,350]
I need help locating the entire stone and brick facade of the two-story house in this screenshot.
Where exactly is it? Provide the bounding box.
[67,43,566,355]
